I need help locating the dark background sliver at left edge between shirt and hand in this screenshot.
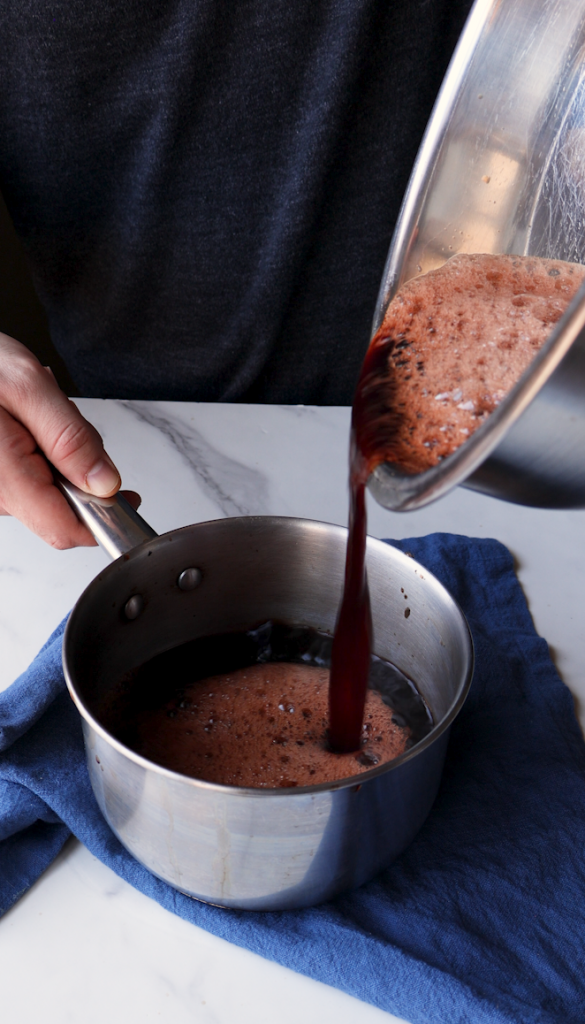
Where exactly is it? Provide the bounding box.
[0,196,79,395]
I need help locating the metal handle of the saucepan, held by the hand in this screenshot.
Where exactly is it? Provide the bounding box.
[53,470,158,559]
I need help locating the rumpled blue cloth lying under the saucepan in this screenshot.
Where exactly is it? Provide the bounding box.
[0,535,585,1024]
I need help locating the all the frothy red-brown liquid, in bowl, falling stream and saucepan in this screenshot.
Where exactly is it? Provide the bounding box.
[108,255,585,787]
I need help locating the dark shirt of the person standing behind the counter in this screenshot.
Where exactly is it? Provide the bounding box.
[0,0,471,404]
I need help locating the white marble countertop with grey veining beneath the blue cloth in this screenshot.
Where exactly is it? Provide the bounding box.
[0,399,585,1024]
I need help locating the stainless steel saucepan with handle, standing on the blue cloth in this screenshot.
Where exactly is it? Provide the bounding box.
[61,483,473,910]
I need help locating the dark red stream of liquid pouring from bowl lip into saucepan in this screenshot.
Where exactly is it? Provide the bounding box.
[329,331,400,754]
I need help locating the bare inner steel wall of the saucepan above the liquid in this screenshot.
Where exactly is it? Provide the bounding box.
[65,517,471,745]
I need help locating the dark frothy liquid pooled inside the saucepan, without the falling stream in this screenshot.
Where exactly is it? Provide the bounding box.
[100,623,432,787]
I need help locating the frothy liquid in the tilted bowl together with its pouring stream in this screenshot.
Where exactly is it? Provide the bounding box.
[329,254,585,753]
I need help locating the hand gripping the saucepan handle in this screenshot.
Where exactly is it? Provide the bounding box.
[0,333,134,549]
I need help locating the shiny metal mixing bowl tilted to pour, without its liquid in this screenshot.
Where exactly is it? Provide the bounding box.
[370,0,585,510]
